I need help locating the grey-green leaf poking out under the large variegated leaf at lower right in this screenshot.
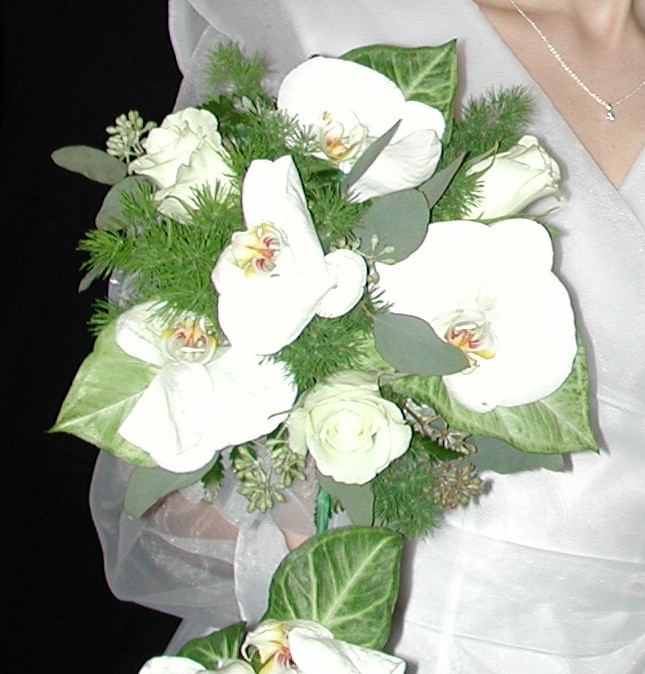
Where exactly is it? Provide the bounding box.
[468,435,564,475]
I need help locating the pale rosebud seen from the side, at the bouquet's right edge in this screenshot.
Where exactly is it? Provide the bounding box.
[465,136,560,220]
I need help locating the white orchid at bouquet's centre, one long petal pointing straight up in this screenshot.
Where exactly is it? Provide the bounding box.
[212,156,367,354]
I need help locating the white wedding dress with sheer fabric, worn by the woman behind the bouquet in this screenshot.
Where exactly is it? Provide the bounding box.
[92,0,645,674]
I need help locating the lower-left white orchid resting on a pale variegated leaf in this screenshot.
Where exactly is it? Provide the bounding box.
[116,302,296,473]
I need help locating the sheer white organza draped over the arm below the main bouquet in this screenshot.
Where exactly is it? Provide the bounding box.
[90,453,348,627]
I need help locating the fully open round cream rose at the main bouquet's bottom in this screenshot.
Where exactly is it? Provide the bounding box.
[287,371,412,484]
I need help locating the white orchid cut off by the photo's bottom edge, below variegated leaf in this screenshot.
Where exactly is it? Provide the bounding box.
[242,620,405,674]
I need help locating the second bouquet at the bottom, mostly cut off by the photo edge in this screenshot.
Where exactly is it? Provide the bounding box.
[139,527,405,674]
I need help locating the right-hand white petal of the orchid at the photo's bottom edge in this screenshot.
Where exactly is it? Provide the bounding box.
[289,628,405,674]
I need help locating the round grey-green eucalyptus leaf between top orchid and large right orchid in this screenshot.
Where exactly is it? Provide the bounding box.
[354,190,430,262]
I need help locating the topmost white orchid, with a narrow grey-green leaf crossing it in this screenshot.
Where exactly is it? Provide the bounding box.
[278,56,445,201]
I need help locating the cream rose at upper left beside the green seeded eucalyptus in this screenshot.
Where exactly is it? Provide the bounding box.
[130,108,231,221]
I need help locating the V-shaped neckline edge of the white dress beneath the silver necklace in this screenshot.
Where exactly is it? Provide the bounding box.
[466,0,645,197]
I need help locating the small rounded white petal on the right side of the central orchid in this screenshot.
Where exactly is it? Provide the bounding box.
[316,249,367,318]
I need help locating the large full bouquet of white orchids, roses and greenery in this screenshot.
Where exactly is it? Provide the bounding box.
[53,42,597,536]
